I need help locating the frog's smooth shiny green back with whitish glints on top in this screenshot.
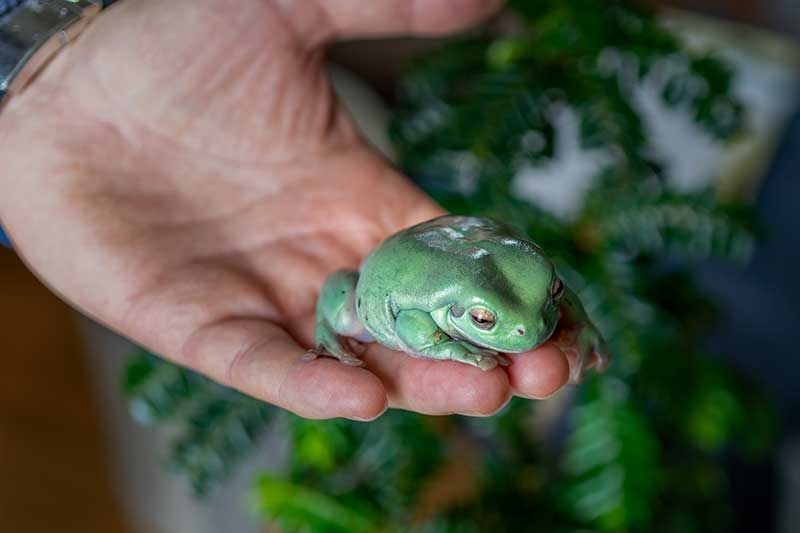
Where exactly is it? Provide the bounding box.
[356,215,541,348]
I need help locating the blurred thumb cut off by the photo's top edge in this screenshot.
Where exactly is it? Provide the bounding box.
[317,0,502,39]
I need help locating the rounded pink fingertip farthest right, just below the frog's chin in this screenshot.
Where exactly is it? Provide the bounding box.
[505,343,570,399]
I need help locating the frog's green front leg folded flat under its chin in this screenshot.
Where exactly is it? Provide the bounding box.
[395,309,506,370]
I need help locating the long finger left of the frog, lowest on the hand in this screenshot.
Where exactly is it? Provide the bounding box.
[184,318,387,420]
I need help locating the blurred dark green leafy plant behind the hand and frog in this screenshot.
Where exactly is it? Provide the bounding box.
[125,0,775,533]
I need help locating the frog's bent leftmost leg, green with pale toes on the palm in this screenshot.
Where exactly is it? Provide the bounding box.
[309,270,366,366]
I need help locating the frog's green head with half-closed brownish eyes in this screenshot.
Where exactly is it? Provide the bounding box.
[448,254,565,353]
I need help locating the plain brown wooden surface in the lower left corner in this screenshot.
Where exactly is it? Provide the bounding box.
[0,247,130,533]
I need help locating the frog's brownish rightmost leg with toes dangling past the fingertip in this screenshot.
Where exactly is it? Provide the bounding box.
[554,288,611,383]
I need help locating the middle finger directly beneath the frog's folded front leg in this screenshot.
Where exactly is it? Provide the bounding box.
[364,344,511,416]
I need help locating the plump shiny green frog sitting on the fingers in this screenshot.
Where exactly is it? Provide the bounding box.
[309,215,610,382]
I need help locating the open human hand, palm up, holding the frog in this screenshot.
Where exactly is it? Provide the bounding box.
[0,0,569,419]
